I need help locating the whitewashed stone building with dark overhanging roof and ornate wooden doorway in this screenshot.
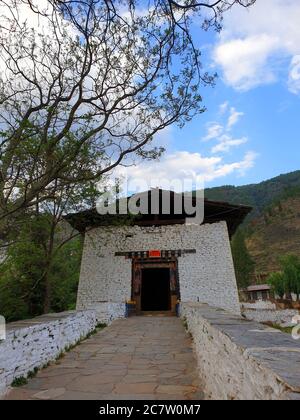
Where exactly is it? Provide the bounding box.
[67,192,251,322]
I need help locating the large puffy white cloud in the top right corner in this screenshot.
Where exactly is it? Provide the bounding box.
[213,0,300,93]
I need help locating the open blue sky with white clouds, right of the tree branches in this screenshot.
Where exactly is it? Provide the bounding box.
[121,0,300,187]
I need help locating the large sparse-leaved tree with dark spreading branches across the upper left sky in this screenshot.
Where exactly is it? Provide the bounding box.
[0,0,255,235]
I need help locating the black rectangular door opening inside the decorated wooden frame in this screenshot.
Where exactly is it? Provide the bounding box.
[141,268,171,311]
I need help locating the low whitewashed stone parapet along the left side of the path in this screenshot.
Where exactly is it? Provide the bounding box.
[0,311,96,396]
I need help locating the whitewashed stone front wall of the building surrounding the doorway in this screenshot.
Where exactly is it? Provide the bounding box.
[77,222,240,319]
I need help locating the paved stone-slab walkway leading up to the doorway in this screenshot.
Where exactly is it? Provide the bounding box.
[7,317,203,400]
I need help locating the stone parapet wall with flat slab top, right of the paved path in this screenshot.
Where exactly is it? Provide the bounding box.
[181,304,300,400]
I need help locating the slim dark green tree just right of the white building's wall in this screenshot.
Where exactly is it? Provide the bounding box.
[231,229,255,288]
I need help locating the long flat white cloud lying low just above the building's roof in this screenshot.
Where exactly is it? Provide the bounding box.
[117,151,257,188]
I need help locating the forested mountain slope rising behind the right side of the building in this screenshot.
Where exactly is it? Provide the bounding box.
[206,171,300,281]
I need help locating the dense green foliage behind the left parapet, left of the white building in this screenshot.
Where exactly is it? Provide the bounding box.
[0,214,82,321]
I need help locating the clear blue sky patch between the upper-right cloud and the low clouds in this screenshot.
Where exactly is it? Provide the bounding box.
[172,69,300,185]
